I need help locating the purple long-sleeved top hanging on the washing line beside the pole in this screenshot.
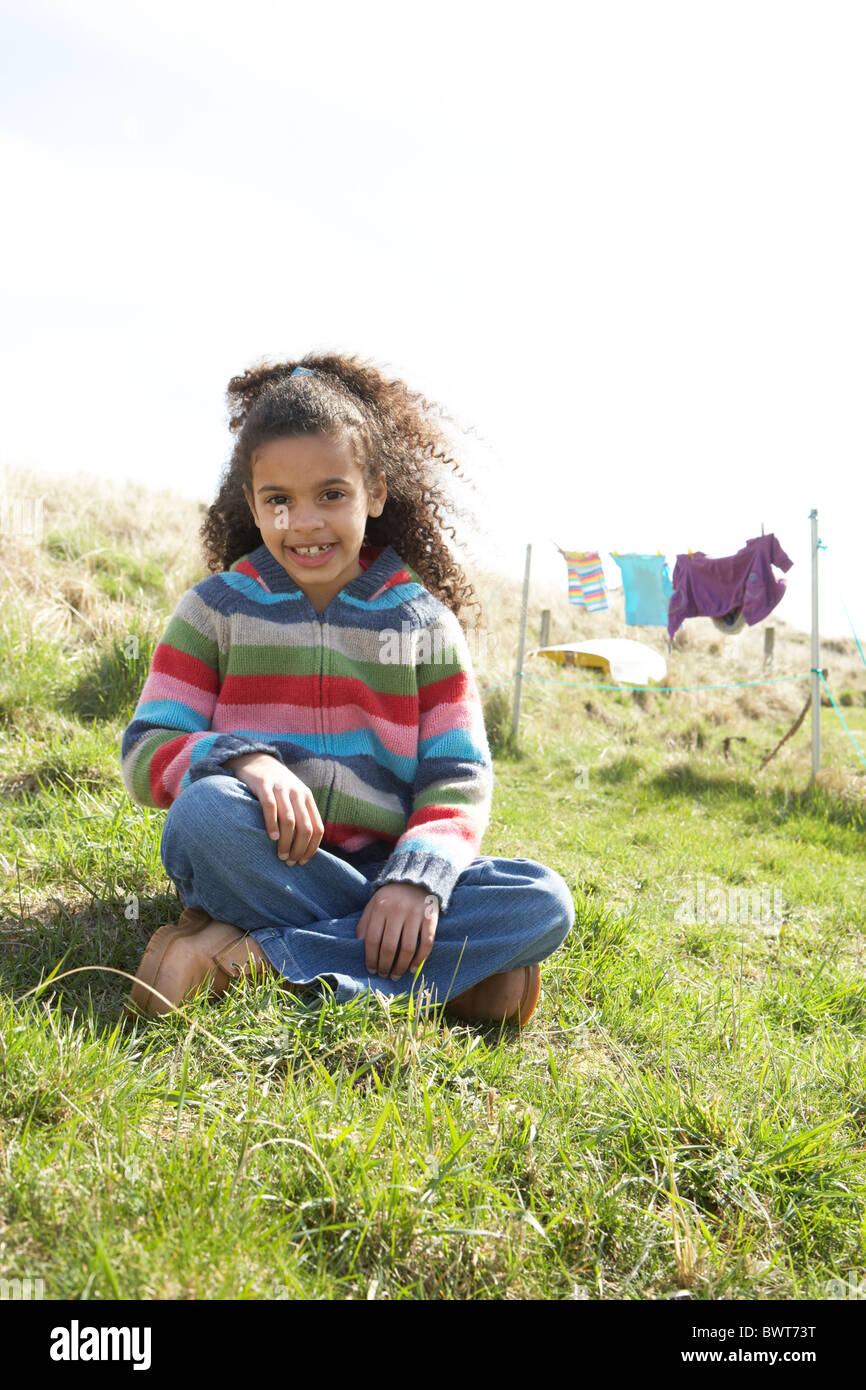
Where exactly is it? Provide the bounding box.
[667,532,794,638]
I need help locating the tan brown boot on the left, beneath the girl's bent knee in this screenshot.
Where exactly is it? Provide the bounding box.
[124,908,271,1019]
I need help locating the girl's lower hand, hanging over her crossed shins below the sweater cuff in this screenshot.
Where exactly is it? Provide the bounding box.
[356,883,439,980]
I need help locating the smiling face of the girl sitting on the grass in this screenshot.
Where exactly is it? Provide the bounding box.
[243,435,386,613]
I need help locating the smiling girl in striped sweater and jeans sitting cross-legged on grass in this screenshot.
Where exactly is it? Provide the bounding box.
[121,354,574,1024]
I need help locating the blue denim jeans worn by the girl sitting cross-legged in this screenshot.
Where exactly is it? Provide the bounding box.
[160,774,574,1004]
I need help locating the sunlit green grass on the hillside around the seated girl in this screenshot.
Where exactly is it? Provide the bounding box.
[0,461,866,1300]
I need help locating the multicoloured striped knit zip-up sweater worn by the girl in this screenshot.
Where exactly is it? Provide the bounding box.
[121,545,492,912]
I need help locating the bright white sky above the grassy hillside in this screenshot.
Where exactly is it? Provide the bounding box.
[0,0,866,645]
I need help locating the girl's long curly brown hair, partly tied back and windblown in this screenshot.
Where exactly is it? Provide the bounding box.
[199,353,482,621]
